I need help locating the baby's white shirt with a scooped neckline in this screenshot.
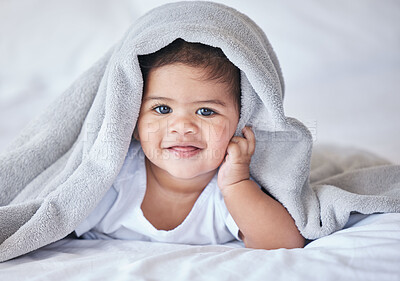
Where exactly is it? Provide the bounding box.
[75,141,241,245]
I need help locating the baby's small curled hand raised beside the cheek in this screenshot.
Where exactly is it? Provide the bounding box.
[218,127,256,192]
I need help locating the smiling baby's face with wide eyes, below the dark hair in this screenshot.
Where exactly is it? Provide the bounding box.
[137,64,239,179]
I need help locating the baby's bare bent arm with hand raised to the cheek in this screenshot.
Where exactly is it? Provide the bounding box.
[218,127,304,249]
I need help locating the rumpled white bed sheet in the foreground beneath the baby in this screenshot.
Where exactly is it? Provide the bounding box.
[0,214,400,281]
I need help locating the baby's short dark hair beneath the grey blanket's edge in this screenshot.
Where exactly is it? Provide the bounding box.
[138,38,241,111]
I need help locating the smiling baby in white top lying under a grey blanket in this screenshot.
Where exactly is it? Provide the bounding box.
[76,39,304,249]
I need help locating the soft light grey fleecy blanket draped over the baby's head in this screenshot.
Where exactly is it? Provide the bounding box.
[0,1,400,261]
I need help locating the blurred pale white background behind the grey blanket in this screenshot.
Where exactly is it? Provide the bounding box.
[0,0,400,164]
